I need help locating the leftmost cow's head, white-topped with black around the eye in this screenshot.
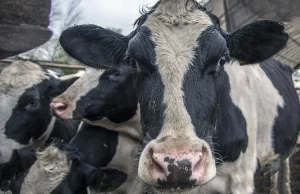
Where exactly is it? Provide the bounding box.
[0,61,78,163]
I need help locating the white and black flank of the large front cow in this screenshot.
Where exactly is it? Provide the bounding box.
[225,59,300,164]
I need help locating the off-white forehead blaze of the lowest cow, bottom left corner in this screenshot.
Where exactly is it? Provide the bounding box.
[21,145,71,194]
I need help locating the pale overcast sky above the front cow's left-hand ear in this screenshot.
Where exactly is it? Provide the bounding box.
[50,0,156,35]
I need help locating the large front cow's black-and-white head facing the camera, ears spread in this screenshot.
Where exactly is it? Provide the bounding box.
[61,0,288,193]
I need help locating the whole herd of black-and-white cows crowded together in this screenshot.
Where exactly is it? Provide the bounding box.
[0,0,300,194]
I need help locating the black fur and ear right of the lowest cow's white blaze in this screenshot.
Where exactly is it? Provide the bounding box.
[51,143,127,194]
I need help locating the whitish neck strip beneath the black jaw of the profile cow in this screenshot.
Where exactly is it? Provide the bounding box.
[82,106,142,141]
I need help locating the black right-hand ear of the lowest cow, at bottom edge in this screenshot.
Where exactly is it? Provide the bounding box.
[86,168,127,192]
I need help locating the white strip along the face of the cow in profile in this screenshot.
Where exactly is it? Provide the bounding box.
[56,68,105,117]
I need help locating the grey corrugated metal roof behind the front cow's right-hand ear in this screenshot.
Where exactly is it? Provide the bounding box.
[220,0,300,67]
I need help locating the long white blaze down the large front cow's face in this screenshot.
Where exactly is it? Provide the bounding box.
[144,0,212,137]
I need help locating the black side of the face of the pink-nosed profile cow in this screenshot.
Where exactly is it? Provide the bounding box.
[73,64,137,123]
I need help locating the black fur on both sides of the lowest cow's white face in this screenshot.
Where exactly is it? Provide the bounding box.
[0,143,127,194]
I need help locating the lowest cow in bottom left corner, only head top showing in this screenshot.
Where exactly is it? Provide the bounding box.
[1,143,127,194]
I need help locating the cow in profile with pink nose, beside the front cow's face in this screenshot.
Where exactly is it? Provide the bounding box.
[51,67,142,194]
